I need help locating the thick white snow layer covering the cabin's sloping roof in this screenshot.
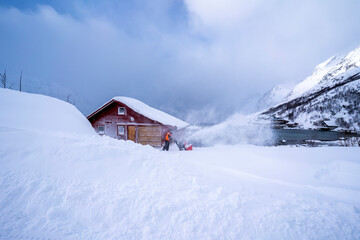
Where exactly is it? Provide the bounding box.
[112,97,190,129]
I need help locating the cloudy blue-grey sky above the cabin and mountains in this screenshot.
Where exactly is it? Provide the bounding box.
[0,0,360,122]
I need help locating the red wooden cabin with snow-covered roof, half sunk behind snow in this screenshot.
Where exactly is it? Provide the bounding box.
[87,97,189,147]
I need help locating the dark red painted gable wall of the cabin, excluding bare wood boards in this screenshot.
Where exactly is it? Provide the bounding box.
[89,102,171,143]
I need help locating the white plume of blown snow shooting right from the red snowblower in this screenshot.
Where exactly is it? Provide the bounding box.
[188,113,273,147]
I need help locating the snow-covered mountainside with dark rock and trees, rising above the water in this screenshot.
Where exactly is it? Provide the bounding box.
[259,47,360,130]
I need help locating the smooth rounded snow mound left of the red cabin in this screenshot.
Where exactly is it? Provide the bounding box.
[0,89,95,135]
